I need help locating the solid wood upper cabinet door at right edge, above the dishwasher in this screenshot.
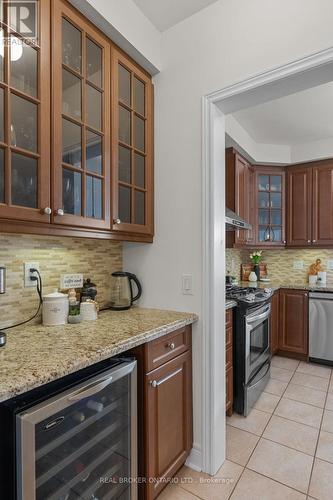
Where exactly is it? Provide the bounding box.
[312,160,333,246]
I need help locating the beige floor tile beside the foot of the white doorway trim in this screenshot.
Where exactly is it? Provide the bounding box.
[226,425,259,465]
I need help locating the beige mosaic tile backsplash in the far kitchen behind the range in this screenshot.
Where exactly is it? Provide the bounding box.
[226,248,333,285]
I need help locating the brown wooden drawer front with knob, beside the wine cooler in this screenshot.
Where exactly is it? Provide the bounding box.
[146,326,191,372]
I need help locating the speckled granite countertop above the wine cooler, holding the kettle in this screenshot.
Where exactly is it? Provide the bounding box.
[0,308,198,402]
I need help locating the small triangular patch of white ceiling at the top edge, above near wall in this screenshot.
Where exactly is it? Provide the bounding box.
[134,0,217,31]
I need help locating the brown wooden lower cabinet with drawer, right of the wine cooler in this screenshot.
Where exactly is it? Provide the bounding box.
[132,326,193,500]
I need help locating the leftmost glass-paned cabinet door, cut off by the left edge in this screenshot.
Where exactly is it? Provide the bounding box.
[0,0,51,223]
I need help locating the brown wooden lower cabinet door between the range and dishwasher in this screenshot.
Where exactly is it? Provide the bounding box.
[278,289,309,359]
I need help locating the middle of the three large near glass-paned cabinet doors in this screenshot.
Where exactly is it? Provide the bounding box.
[52,0,111,229]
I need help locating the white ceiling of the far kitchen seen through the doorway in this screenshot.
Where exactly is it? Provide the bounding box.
[233,82,333,146]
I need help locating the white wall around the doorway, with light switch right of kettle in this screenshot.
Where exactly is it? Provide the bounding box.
[124,0,333,468]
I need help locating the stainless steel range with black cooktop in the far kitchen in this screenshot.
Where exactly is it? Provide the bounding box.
[226,285,273,416]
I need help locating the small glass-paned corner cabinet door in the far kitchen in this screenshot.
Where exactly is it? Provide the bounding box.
[256,167,286,246]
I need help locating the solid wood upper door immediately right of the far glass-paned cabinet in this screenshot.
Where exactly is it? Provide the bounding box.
[287,165,312,247]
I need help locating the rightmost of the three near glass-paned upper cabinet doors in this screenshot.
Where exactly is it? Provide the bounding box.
[111,49,153,235]
